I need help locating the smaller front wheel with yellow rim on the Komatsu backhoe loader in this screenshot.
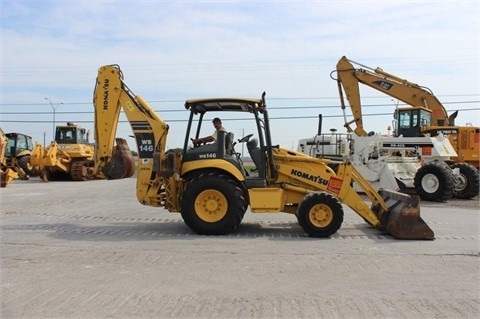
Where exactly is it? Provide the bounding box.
[297,192,343,237]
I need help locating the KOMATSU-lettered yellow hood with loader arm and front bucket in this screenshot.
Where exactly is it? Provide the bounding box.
[274,148,434,239]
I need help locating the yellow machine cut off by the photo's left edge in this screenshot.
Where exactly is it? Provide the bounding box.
[0,128,34,187]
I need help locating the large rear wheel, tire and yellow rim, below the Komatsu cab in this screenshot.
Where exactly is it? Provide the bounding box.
[181,173,247,235]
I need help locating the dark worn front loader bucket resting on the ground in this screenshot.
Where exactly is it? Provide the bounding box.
[372,189,435,240]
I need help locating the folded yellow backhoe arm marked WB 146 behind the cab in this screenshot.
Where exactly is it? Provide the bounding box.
[93,65,178,209]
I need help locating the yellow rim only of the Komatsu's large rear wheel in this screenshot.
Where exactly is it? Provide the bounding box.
[195,189,228,223]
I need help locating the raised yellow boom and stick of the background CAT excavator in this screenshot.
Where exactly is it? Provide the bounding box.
[336,56,457,136]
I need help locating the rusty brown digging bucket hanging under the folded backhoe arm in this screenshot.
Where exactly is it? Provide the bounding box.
[102,138,135,179]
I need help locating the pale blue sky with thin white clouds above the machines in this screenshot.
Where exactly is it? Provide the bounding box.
[0,0,480,149]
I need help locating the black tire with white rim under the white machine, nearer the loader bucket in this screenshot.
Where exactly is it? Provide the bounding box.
[414,161,454,202]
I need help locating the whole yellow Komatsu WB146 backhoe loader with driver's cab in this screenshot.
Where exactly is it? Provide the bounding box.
[94,65,434,239]
